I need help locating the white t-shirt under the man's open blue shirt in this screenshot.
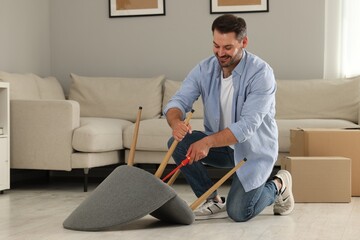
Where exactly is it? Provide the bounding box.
[220,73,234,147]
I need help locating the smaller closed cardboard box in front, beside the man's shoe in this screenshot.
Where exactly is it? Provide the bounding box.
[282,157,351,203]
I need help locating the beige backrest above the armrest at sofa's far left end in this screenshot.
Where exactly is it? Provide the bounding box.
[0,71,65,100]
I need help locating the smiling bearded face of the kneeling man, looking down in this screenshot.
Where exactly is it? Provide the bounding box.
[213,29,247,68]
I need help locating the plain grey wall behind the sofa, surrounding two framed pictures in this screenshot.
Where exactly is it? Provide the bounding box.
[0,0,325,91]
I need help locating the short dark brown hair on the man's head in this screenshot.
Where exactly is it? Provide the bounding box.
[211,14,246,40]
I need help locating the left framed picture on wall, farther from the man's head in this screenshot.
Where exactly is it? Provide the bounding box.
[109,0,165,18]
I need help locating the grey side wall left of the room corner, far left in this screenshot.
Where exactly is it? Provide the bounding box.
[0,0,51,76]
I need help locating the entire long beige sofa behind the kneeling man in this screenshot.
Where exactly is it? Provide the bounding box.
[0,72,360,189]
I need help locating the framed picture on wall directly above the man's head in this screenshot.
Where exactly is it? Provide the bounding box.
[210,0,269,14]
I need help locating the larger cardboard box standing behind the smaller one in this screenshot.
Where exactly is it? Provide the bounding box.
[290,128,360,196]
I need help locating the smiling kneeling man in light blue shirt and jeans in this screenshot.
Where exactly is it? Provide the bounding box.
[164,14,294,222]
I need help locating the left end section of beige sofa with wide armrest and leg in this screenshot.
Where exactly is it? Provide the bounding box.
[0,72,132,191]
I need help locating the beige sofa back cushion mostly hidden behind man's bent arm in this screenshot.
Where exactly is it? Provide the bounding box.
[163,79,204,119]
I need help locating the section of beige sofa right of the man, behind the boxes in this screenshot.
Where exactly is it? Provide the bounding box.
[276,77,360,163]
